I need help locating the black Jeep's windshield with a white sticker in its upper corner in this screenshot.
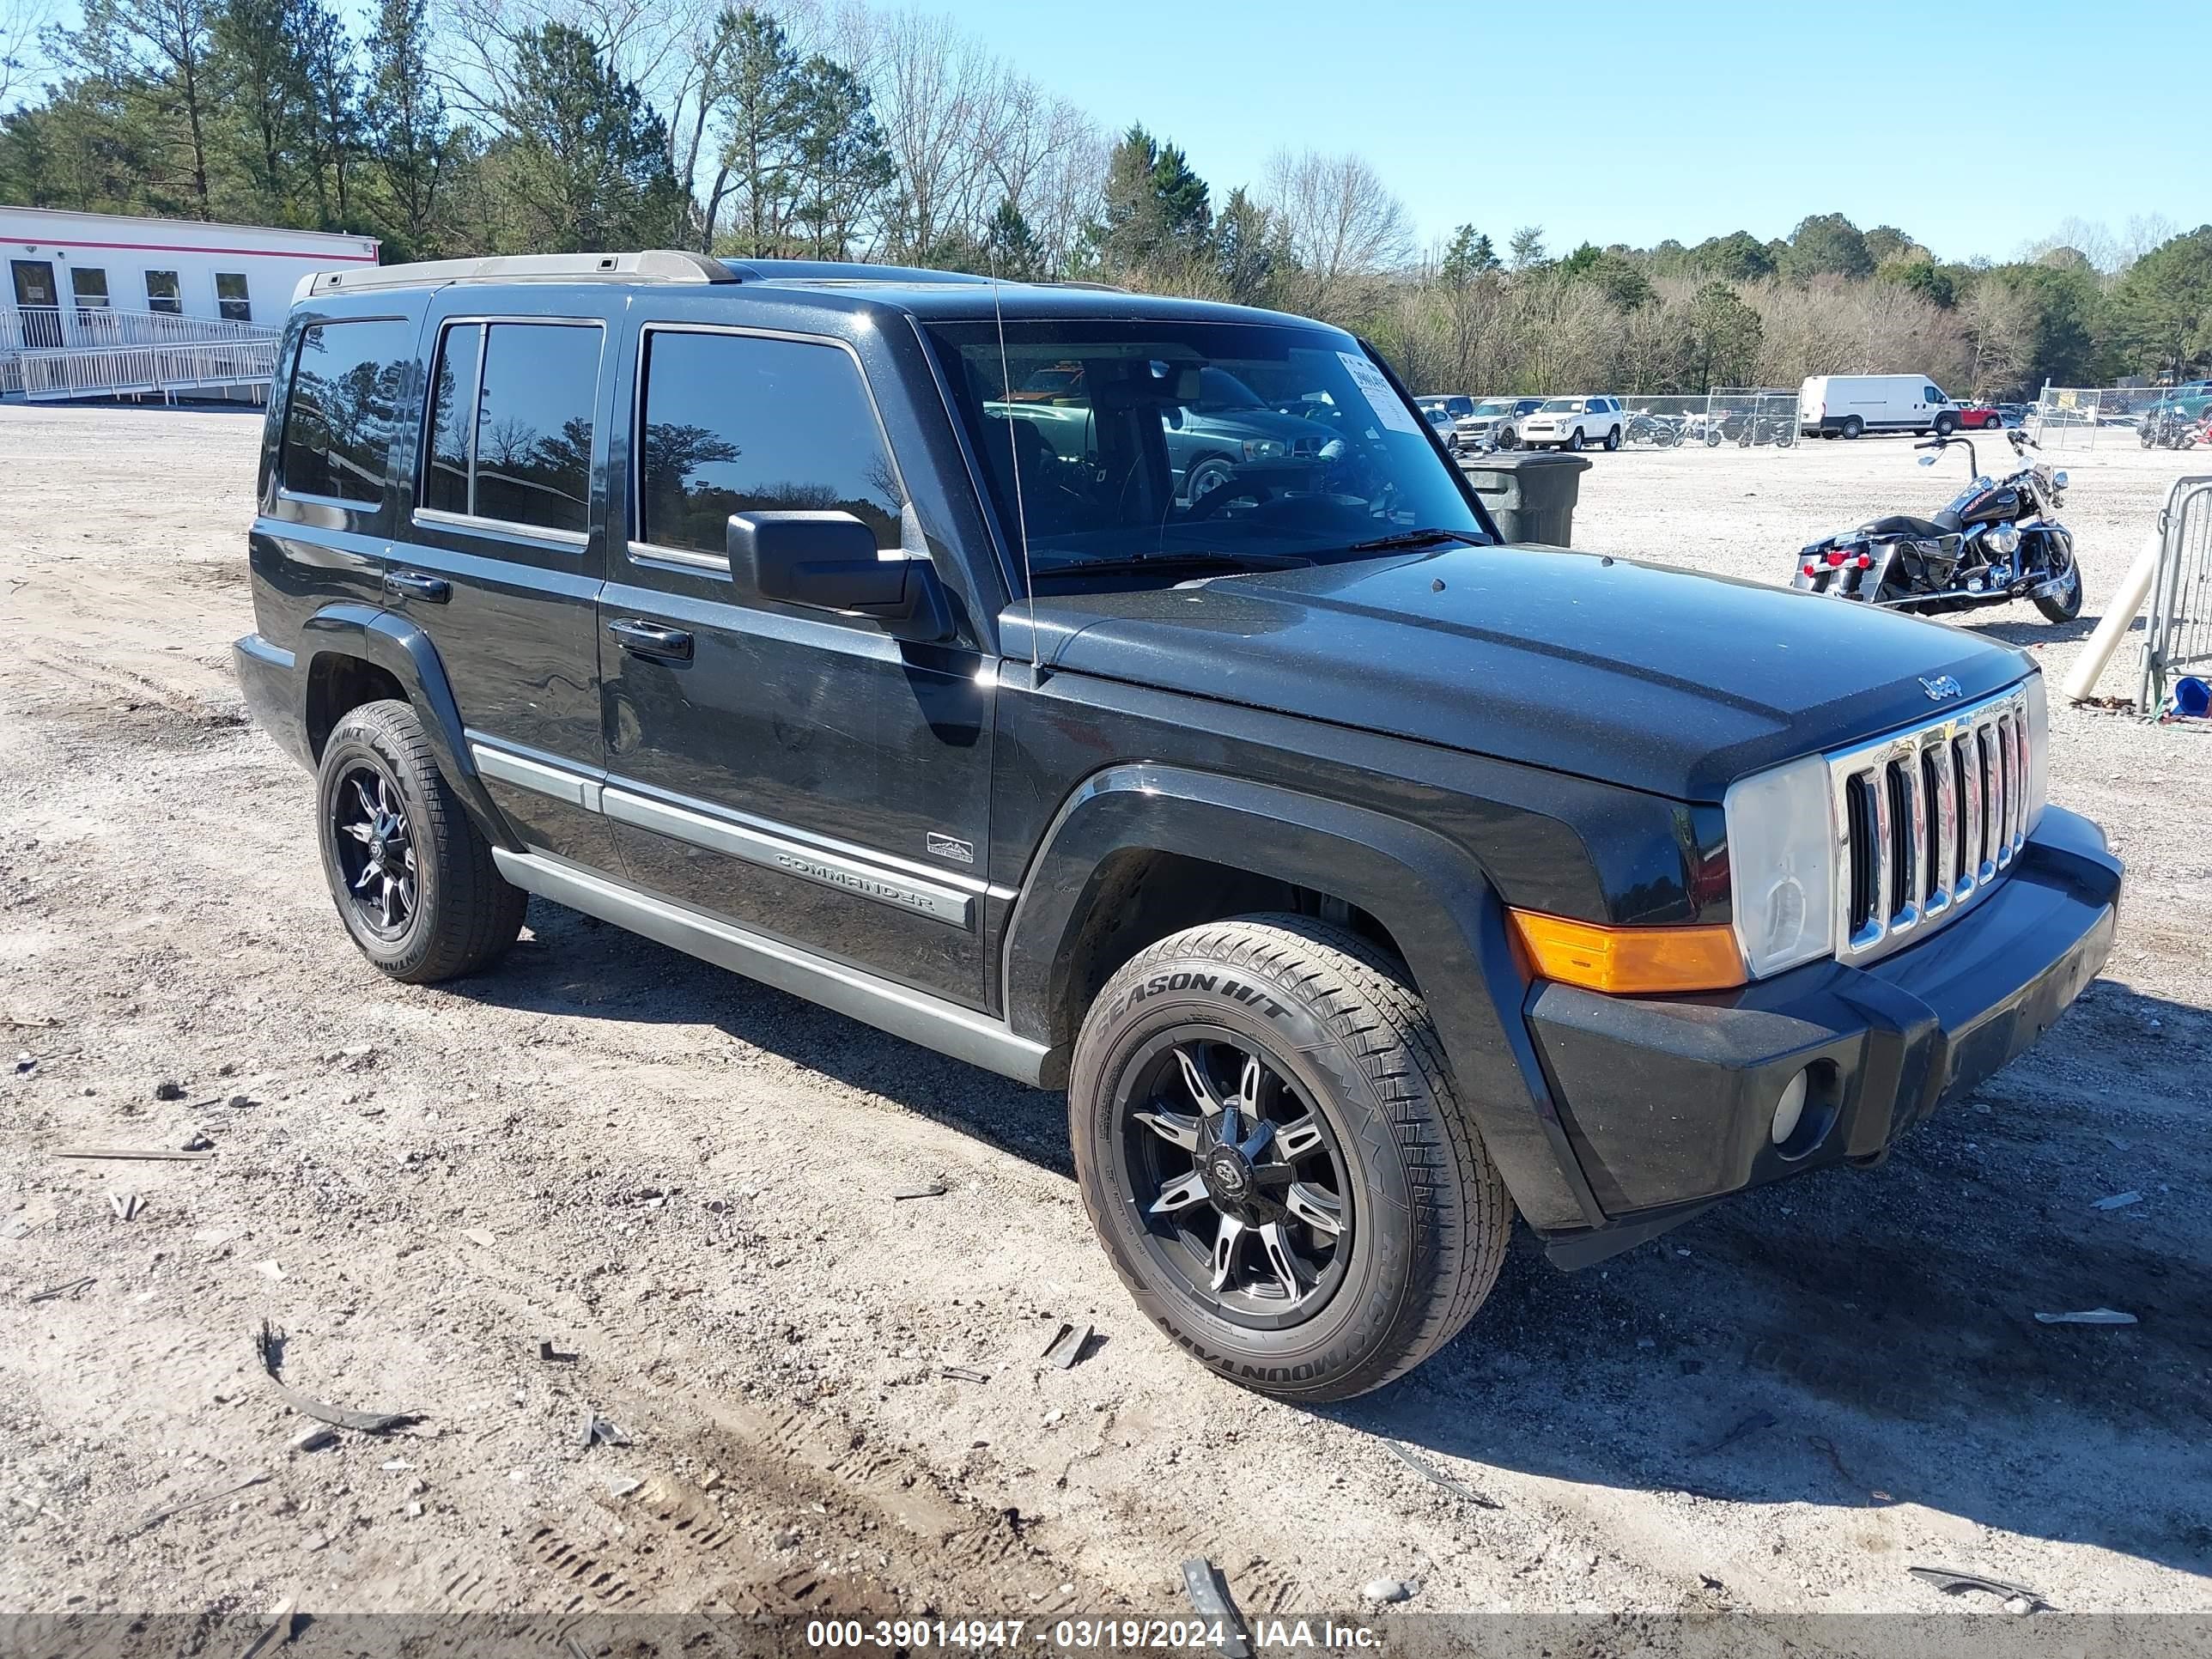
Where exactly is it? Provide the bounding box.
[927,321,1489,586]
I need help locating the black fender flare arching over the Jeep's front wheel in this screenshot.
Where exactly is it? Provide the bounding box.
[1000,763,1606,1232]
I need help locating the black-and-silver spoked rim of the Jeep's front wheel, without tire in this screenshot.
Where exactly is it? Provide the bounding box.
[1115,1024,1356,1329]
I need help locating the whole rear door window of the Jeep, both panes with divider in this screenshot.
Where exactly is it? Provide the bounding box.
[422,323,599,535]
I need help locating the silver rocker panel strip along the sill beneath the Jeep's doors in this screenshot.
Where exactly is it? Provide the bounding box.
[491,848,1046,1086]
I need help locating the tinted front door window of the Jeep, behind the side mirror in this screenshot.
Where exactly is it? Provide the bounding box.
[637,330,907,553]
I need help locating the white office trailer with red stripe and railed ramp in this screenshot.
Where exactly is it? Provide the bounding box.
[0,206,376,398]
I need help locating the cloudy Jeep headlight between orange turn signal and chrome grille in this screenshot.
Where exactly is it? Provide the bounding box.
[1723,754,1836,980]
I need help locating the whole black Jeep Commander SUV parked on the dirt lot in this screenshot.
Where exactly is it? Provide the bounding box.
[237,252,2119,1401]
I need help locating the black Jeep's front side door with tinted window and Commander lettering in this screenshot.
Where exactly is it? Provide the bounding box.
[599,321,998,1006]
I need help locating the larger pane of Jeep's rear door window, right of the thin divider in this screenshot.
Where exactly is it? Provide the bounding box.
[473,323,599,535]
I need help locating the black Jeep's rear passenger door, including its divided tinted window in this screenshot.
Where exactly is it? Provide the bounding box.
[385,288,617,869]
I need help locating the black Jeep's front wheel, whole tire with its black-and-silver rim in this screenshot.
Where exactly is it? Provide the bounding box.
[1068,915,1513,1402]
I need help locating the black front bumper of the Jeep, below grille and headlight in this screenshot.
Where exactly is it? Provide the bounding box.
[1526,807,2121,1265]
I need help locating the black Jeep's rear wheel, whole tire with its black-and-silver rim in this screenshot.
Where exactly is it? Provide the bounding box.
[314,702,529,984]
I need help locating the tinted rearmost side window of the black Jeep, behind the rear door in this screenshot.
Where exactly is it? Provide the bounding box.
[279,321,414,502]
